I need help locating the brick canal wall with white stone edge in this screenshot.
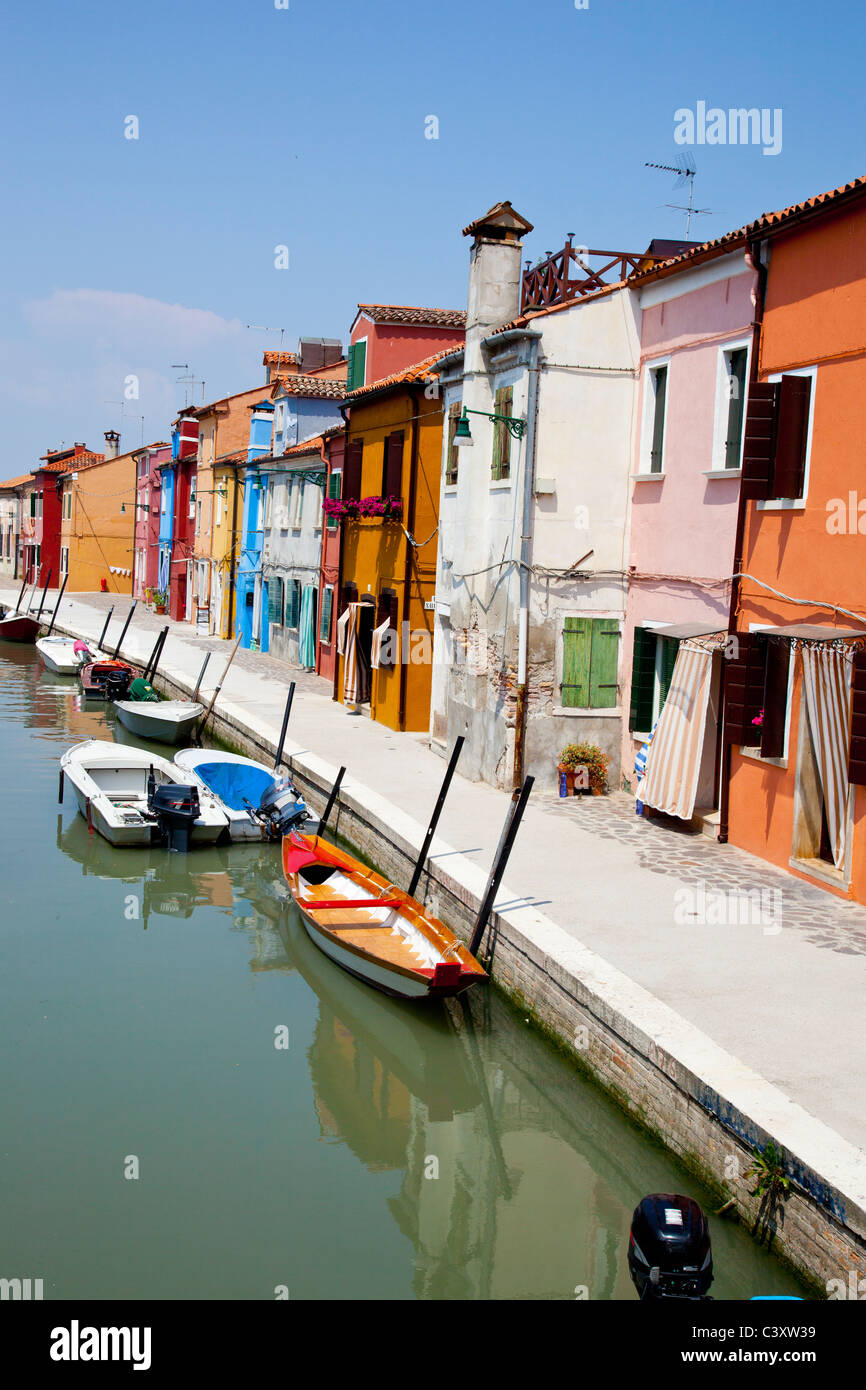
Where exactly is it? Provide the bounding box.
[48,617,866,1297]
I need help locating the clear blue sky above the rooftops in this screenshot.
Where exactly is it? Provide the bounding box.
[0,0,866,477]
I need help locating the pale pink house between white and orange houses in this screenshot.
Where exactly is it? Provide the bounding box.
[623,234,758,828]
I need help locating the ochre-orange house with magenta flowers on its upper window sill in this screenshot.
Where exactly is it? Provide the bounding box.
[335,352,443,731]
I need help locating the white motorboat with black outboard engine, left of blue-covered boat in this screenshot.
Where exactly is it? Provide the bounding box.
[60,738,228,849]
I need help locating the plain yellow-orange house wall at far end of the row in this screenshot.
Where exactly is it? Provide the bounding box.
[58,431,140,594]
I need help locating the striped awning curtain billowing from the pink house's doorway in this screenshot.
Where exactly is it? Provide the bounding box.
[638,642,713,820]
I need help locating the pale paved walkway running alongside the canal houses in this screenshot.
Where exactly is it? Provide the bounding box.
[16,592,866,1148]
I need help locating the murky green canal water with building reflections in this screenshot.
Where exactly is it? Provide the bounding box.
[0,644,802,1300]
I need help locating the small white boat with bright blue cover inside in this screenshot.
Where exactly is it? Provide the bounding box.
[174,748,318,840]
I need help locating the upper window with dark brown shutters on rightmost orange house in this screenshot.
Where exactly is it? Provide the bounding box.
[742,368,815,502]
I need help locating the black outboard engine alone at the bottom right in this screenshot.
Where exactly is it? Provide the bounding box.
[628,1193,713,1300]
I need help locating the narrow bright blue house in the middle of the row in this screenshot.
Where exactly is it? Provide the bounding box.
[236,400,274,652]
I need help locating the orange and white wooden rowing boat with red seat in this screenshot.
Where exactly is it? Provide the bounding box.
[282,831,487,999]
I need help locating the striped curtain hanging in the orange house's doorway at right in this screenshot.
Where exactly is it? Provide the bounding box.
[802,645,852,869]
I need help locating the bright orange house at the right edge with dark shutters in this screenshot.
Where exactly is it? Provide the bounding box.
[721,179,866,902]
